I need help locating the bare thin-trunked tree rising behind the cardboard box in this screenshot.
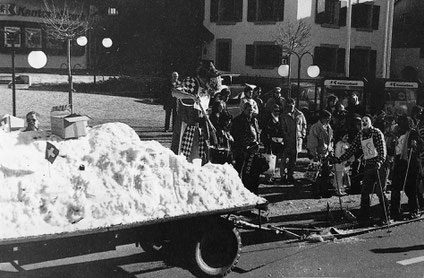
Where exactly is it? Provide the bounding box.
[43,0,91,112]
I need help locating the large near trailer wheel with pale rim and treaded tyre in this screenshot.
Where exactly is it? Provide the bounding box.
[191,219,241,277]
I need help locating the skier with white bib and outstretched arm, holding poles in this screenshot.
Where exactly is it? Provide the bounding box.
[331,115,390,224]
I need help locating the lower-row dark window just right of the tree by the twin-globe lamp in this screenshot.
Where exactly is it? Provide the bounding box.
[314,46,346,74]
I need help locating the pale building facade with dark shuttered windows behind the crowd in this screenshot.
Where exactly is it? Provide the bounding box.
[203,0,393,84]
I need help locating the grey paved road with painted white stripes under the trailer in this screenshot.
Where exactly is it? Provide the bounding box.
[0,222,424,278]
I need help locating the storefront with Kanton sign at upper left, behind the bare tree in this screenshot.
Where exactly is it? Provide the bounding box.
[0,0,88,72]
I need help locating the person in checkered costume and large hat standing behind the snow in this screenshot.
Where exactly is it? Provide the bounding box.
[171,61,221,163]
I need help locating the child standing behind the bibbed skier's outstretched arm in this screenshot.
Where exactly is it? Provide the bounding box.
[333,130,350,196]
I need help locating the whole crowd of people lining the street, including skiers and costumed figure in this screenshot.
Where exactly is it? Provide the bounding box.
[165,64,424,226]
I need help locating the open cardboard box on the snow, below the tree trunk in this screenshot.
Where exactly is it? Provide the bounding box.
[50,111,90,139]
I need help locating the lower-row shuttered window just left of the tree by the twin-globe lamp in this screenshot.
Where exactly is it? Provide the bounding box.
[246,42,281,69]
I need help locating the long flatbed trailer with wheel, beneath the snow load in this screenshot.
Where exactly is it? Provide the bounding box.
[0,203,267,277]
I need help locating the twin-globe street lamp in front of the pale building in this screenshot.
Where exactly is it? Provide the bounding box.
[278,51,320,100]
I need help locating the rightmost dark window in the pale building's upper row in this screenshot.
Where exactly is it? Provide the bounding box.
[352,2,380,30]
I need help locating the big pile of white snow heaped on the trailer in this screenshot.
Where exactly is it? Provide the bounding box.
[0,123,265,240]
